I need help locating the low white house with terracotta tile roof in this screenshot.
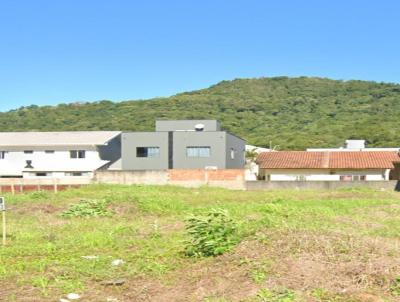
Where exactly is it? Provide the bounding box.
[256,151,400,181]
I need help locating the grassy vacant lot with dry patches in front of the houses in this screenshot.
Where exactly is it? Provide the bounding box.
[0,186,400,302]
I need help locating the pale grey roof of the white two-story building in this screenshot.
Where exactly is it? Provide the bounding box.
[0,131,121,147]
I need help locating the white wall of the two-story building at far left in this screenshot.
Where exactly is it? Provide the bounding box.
[0,147,107,178]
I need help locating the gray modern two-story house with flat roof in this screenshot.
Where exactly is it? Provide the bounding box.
[110,120,245,170]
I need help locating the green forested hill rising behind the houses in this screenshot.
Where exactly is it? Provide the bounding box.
[0,77,400,149]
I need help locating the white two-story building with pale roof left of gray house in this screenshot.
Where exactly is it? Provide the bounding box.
[0,131,121,178]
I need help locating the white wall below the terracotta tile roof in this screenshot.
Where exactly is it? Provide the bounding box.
[260,169,390,181]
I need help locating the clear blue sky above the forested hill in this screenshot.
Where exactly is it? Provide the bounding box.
[0,0,400,111]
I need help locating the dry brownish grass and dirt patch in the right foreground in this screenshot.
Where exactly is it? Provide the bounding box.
[104,232,400,302]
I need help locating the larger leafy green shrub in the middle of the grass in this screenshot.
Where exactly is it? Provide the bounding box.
[185,209,239,257]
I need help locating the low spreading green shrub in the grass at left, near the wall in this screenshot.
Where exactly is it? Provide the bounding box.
[61,199,111,217]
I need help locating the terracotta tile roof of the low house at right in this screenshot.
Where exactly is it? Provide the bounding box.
[257,151,400,169]
